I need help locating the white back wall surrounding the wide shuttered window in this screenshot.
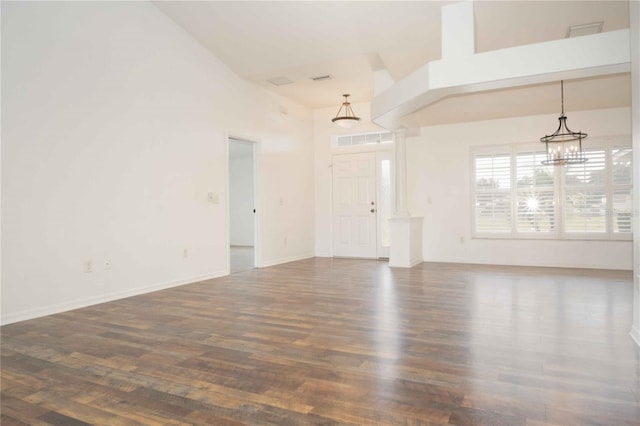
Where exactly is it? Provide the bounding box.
[407,108,633,269]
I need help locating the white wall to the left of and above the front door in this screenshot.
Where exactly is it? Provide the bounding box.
[313,100,384,257]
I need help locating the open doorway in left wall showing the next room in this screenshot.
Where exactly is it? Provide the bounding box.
[228,137,258,274]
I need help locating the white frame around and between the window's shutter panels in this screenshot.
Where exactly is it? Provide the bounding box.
[470,135,638,241]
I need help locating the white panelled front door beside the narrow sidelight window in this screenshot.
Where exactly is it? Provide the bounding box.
[333,152,378,258]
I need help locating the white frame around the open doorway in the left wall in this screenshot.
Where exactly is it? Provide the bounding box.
[224,134,262,275]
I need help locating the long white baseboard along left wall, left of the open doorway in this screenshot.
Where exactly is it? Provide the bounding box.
[0,271,229,325]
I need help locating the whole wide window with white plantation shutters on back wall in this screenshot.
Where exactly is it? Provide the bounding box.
[473,137,633,239]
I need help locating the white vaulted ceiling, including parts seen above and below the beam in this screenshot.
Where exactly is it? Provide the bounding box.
[154,0,631,125]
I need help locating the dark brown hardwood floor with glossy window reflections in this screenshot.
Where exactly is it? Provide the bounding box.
[1,258,640,426]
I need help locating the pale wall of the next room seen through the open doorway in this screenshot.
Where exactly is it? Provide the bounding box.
[229,153,254,246]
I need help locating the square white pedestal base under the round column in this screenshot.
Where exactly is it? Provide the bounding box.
[389,217,424,268]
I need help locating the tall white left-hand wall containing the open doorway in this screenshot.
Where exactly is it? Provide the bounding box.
[1,2,314,323]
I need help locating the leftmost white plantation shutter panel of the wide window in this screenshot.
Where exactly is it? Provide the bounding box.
[475,154,511,233]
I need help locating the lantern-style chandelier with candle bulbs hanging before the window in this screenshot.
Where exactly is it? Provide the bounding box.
[540,80,587,166]
